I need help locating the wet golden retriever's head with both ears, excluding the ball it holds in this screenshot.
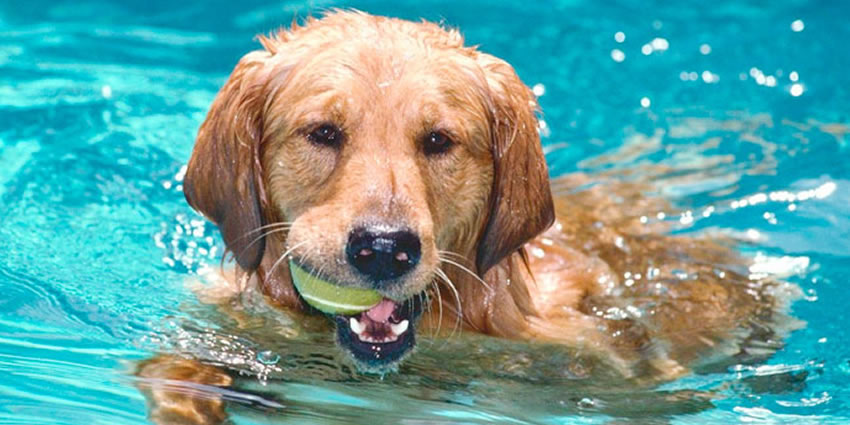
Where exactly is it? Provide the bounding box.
[184,12,553,370]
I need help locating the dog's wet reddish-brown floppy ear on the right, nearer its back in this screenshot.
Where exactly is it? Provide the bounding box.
[476,54,555,275]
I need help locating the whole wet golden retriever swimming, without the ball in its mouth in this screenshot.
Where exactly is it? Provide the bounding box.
[138,11,796,423]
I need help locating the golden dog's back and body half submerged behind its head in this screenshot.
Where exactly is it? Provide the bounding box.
[526,175,800,380]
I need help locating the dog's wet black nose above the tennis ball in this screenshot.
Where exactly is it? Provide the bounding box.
[345,227,421,283]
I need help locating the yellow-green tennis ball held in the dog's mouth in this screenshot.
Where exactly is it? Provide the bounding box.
[289,261,384,315]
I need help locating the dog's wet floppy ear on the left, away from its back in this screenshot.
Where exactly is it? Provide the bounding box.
[183,51,268,272]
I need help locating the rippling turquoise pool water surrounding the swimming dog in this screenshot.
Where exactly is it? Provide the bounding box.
[0,0,850,424]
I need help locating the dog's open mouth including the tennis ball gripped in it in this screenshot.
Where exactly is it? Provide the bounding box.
[290,263,425,373]
